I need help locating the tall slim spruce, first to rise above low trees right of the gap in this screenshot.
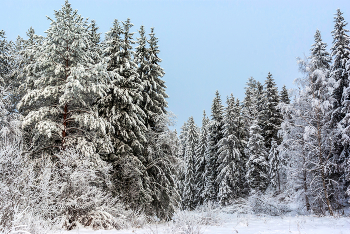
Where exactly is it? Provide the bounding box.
[203,91,224,202]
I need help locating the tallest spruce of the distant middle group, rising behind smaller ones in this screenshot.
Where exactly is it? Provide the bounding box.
[261,73,282,149]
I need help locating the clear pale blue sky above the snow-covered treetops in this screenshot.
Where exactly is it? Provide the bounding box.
[0,0,350,129]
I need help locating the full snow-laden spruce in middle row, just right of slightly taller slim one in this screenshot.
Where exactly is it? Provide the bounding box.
[216,94,242,205]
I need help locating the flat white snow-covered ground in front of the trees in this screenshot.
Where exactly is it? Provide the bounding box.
[61,212,350,234]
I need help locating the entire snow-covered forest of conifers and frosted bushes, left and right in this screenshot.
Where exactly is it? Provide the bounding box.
[0,0,350,234]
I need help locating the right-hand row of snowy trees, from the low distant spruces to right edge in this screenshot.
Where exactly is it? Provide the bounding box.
[179,9,350,215]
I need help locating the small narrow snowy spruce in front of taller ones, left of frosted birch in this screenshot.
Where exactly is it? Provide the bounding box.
[268,139,281,191]
